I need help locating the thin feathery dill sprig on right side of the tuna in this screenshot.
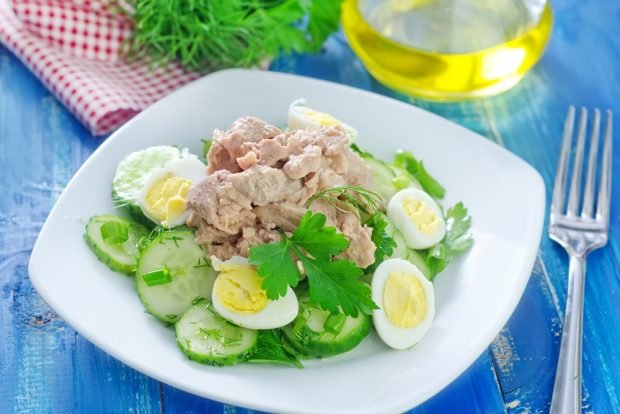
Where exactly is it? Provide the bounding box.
[307,185,383,216]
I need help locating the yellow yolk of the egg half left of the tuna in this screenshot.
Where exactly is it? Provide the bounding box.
[146,175,192,226]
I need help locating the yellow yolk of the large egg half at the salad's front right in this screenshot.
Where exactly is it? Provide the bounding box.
[383,272,428,328]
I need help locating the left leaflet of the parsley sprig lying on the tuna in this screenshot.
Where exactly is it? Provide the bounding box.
[249,237,301,300]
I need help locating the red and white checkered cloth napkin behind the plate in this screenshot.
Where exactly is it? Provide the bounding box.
[0,0,199,135]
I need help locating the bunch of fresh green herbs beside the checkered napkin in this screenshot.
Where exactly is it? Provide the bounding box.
[121,0,341,71]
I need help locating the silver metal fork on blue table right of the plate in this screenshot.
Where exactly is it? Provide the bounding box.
[549,106,613,414]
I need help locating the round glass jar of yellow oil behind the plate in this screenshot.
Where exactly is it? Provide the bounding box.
[342,0,553,100]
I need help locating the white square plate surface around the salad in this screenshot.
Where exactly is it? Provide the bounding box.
[29,70,545,413]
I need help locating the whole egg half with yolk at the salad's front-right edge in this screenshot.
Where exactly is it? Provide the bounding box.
[372,259,435,349]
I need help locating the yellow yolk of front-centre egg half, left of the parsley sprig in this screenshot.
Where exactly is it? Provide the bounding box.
[213,263,268,314]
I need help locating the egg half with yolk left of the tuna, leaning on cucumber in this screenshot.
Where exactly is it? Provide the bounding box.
[138,158,207,227]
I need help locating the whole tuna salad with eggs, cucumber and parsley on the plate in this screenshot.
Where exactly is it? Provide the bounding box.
[84,100,473,367]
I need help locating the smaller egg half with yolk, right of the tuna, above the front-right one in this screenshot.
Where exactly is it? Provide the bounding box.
[387,188,446,249]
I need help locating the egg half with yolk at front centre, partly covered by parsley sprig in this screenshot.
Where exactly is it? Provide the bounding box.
[211,256,299,329]
